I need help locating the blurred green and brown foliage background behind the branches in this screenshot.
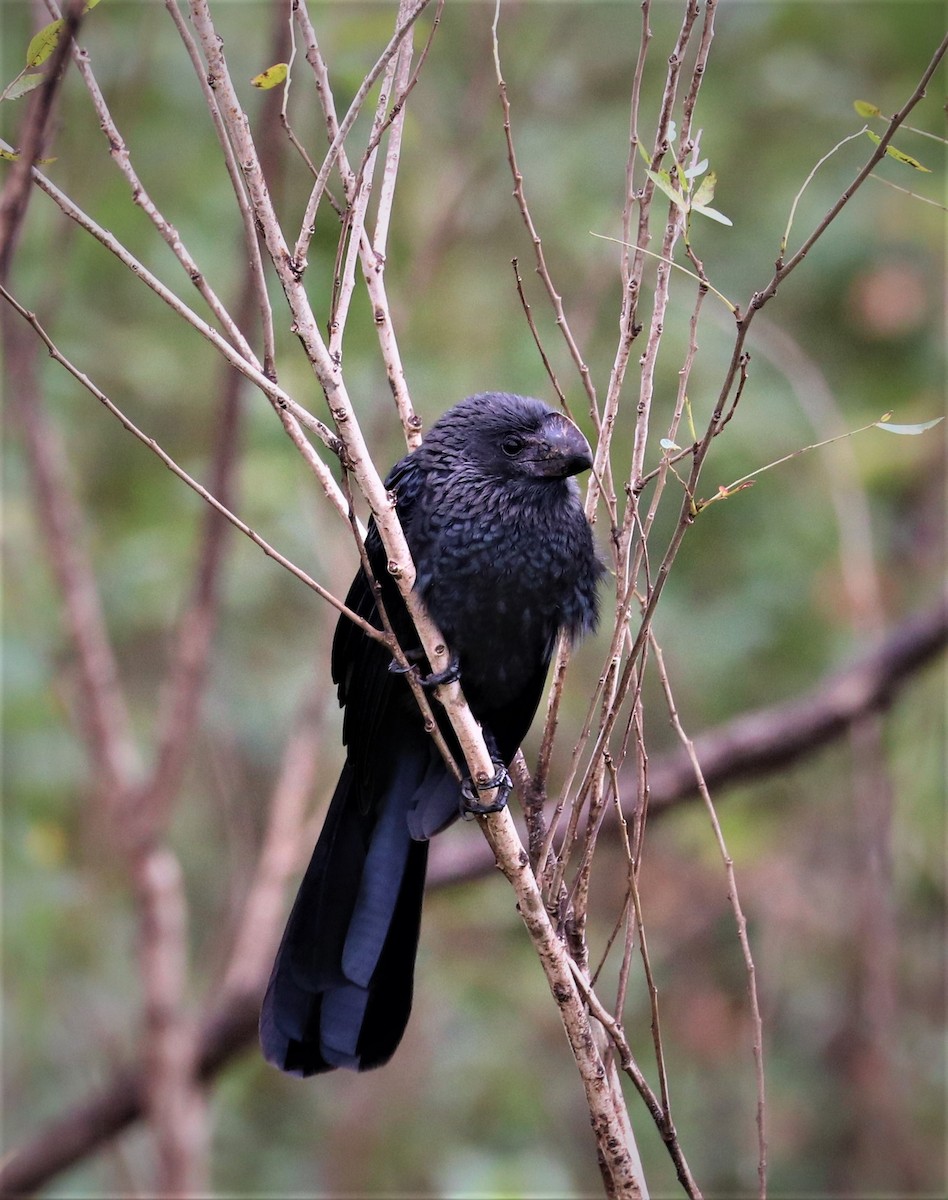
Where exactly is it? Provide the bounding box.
[0,0,946,1196]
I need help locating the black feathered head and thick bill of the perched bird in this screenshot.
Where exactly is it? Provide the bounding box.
[422,391,593,480]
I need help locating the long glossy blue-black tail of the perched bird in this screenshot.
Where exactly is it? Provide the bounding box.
[260,763,428,1075]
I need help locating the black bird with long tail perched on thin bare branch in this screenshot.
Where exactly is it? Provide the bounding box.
[260,392,602,1075]
